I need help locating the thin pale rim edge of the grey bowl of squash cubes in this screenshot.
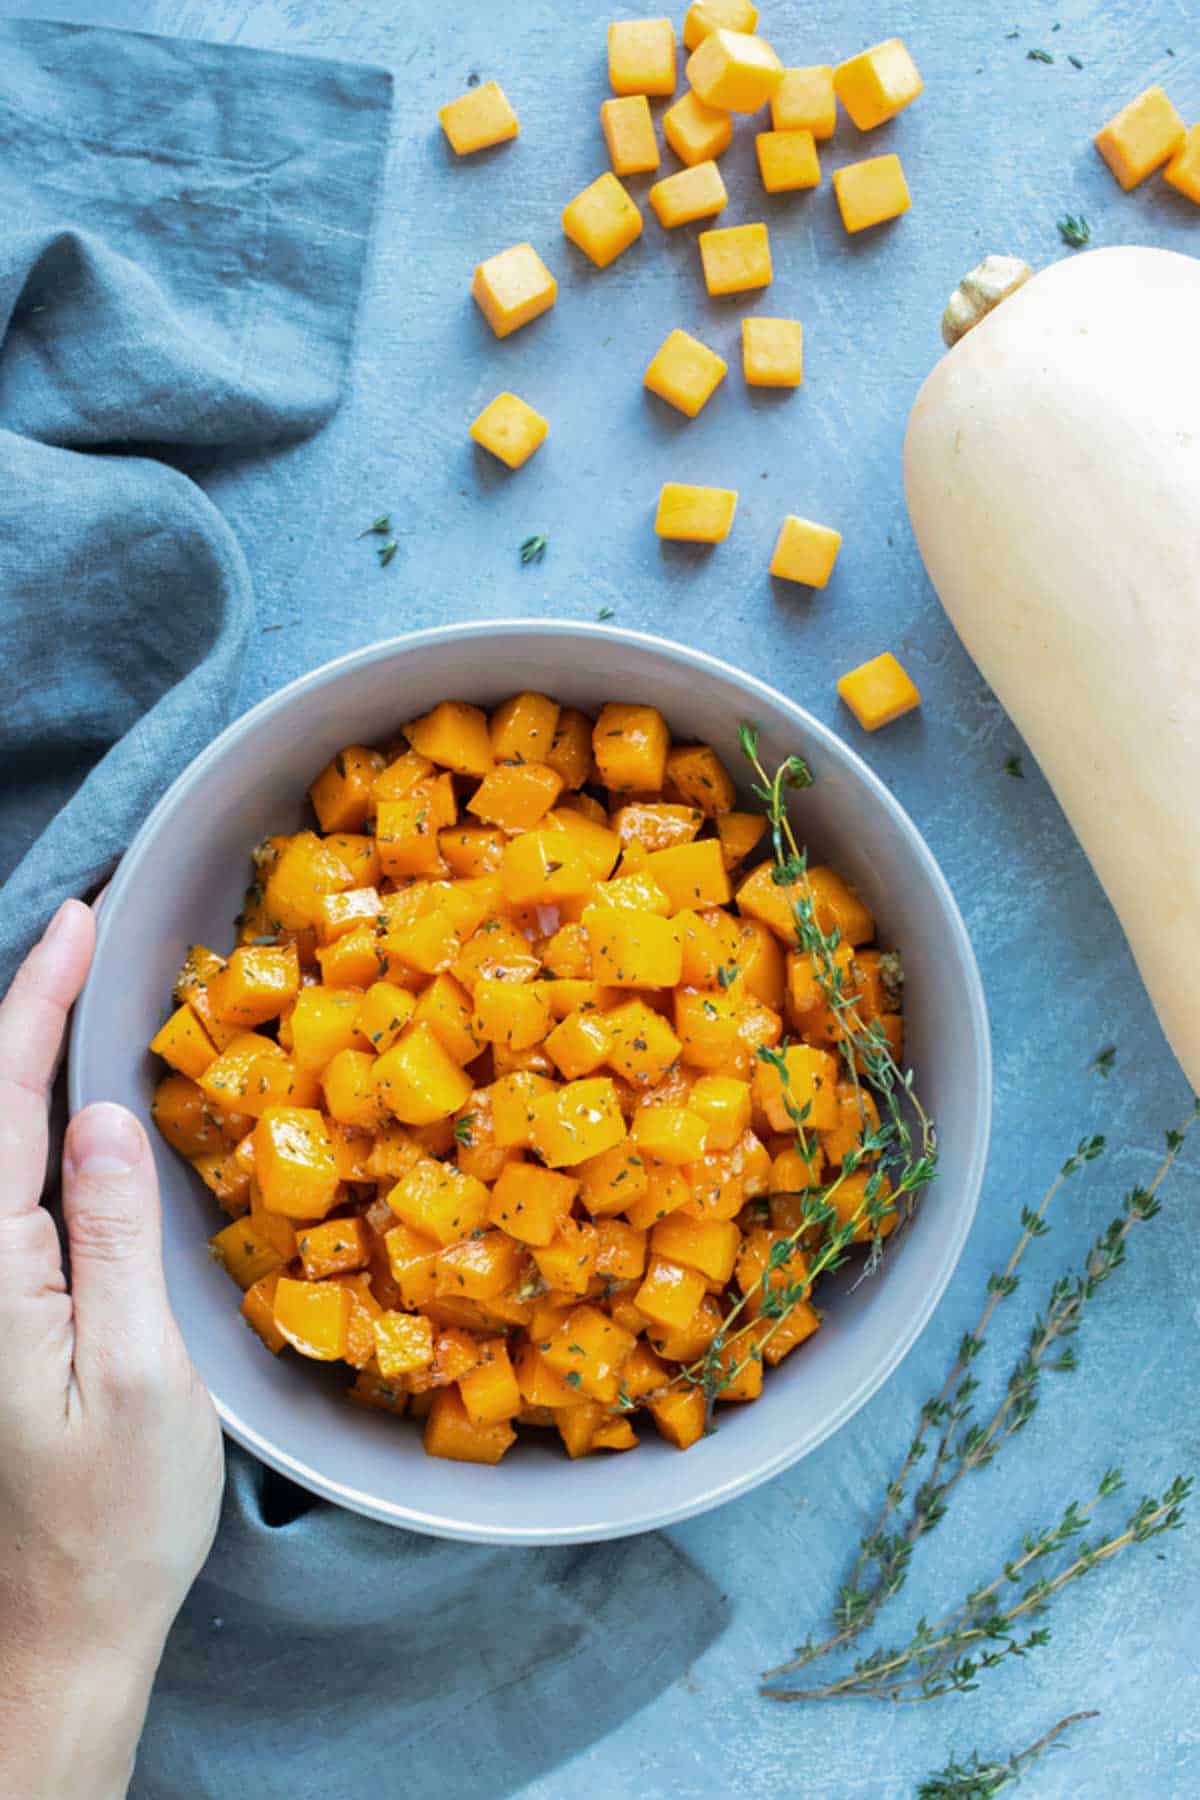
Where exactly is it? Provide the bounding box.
[67,617,993,1548]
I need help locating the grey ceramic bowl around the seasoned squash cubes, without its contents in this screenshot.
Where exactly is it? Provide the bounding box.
[70,621,991,1544]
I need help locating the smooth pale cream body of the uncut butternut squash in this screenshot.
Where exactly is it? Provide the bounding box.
[905,248,1200,1091]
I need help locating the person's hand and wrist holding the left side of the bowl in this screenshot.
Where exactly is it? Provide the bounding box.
[0,900,223,1800]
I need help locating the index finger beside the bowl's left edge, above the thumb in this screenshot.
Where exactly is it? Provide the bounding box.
[0,900,95,1217]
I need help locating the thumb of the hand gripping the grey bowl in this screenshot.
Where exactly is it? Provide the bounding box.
[63,1103,171,1390]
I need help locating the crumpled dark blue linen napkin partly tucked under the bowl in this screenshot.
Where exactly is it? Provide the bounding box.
[0,22,725,1800]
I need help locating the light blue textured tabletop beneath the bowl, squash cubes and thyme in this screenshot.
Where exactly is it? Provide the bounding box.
[11,0,1200,1800]
